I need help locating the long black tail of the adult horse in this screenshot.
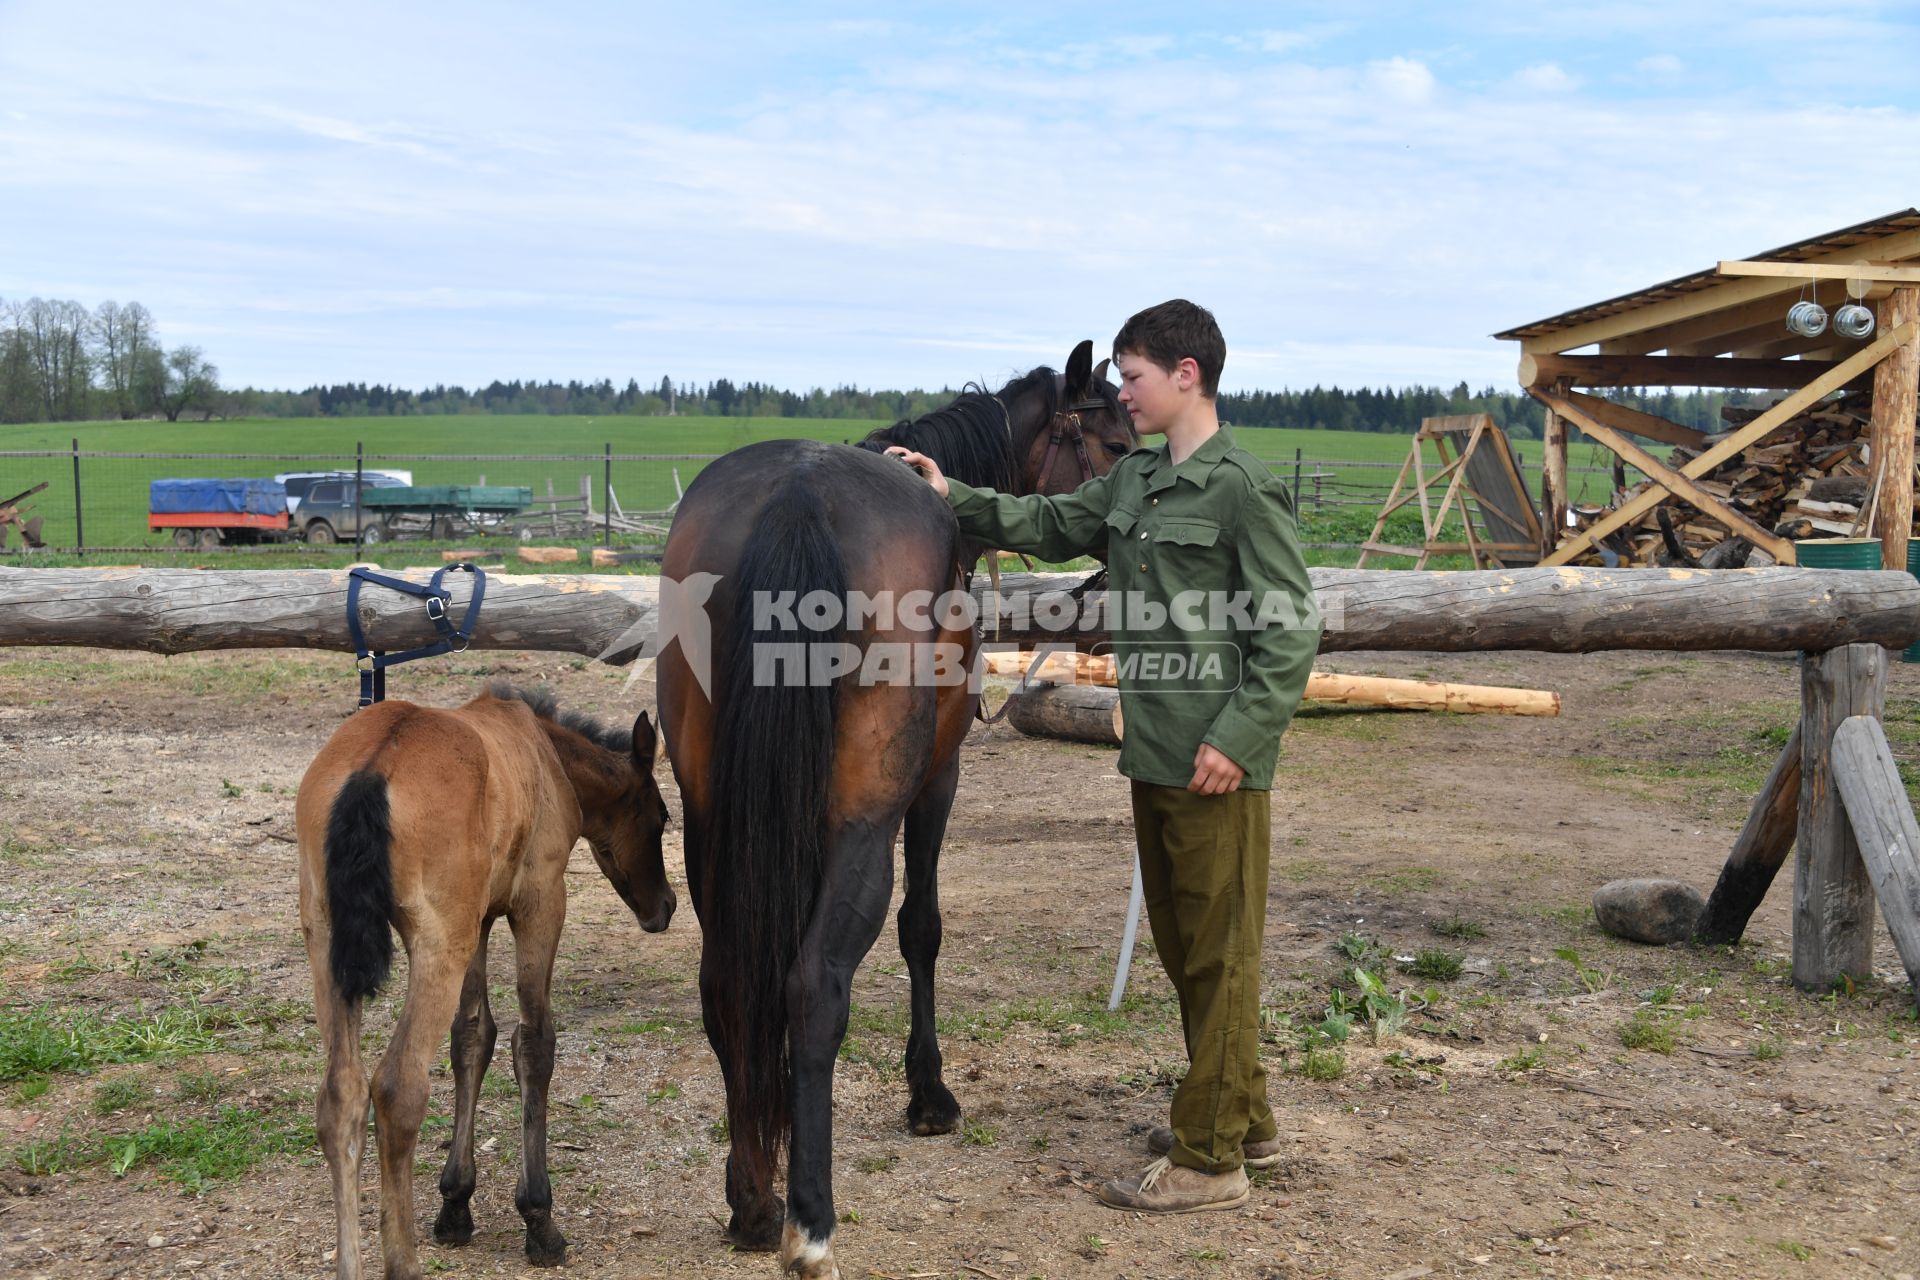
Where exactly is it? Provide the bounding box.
[701,480,847,1161]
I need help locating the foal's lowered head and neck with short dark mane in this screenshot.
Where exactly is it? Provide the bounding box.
[490,683,674,933]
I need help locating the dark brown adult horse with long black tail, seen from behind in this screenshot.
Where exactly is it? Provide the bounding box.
[657,344,1139,1278]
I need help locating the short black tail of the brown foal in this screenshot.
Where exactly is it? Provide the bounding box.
[326,770,394,1006]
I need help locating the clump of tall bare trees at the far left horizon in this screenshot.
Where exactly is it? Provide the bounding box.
[0,297,228,422]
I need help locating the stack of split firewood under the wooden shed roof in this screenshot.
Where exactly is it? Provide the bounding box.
[1582,391,1920,568]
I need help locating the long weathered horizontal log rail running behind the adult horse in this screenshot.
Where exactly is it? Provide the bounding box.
[0,568,1920,662]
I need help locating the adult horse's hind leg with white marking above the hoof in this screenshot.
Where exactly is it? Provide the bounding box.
[780,821,893,1280]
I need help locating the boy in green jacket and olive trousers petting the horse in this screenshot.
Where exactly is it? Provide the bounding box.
[889,299,1319,1213]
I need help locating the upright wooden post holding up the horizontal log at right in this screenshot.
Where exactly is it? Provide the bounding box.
[1793,645,1887,992]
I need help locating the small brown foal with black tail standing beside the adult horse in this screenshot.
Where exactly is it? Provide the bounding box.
[296,685,674,1280]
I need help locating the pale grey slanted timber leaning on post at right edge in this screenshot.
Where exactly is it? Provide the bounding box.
[1834,716,1920,996]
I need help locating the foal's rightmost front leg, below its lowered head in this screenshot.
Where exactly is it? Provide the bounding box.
[507,898,566,1267]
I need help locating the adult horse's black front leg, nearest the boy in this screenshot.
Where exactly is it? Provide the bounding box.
[899,750,960,1134]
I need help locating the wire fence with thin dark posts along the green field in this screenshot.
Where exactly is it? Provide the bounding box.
[0,443,1643,553]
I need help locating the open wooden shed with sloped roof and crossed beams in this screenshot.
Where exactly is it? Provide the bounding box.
[1496,209,1920,568]
